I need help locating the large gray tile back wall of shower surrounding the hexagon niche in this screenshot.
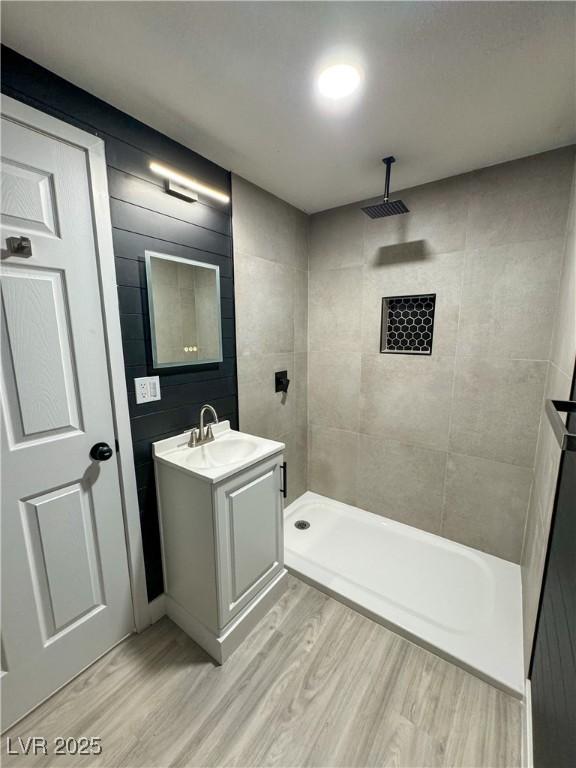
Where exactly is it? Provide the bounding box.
[308,148,575,564]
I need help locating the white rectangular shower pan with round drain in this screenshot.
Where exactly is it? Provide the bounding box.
[284,491,524,696]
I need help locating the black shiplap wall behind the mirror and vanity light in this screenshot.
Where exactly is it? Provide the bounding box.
[2,46,238,599]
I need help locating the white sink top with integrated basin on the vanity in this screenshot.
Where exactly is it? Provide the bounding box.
[154,421,285,483]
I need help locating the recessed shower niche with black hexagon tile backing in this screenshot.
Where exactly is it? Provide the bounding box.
[380,293,436,355]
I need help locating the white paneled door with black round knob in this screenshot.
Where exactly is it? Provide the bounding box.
[0,103,134,728]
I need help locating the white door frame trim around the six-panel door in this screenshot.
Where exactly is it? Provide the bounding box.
[2,95,151,632]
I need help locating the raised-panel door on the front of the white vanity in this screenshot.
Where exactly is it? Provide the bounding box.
[215,456,284,628]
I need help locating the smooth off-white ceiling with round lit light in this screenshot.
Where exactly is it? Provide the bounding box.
[2,2,576,212]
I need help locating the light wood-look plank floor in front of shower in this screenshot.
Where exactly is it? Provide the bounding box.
[2,577,521,768]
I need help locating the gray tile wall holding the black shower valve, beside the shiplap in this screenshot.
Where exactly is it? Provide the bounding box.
[232,176,308,502]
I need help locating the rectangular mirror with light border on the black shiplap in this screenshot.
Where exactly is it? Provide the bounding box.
[146,251,222,368]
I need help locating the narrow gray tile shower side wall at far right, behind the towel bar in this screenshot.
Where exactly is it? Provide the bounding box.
[522,156,576,671]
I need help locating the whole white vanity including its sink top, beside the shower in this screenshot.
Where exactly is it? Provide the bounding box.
[154,425,287,663]
